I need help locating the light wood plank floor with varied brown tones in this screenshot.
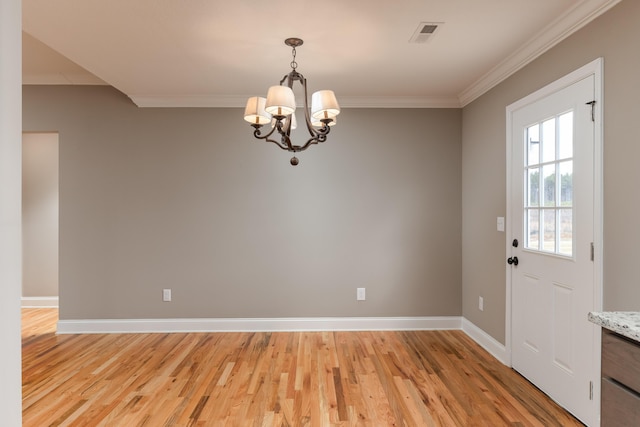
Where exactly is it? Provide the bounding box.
[22,309,582,427]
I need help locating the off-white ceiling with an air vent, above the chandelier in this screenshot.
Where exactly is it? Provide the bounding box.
[22,0,620,107]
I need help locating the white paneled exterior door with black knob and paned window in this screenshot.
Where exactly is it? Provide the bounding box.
[507,61,599,425]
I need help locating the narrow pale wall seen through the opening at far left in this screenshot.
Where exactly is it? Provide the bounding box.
[22,133,58,297]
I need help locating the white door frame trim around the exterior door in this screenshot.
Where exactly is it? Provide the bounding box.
[505,58,604,407]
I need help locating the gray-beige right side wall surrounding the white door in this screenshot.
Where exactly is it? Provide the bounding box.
[462,0,640,342]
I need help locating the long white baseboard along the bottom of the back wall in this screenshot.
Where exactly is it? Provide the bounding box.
[58,316,462,334]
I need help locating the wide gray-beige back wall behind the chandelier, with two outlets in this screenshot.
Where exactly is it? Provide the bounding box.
[23,86,462,319]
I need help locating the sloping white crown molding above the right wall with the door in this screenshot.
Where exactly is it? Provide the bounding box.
[458,0,621,107]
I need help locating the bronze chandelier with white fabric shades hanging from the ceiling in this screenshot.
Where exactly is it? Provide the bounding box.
[244,37,340,166]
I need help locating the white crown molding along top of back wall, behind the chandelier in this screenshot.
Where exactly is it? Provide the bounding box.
[129,95,461,108]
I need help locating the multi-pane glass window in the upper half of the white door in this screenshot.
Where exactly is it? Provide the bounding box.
[524,111,574,256]
